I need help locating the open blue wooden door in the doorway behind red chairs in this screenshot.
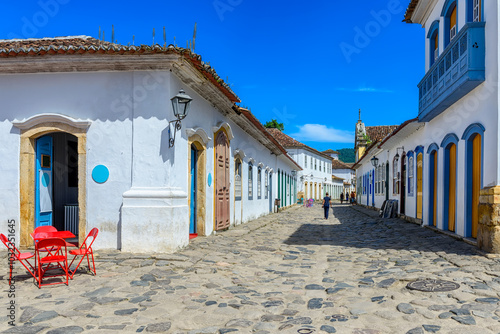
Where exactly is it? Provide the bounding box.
[35,136,53,227]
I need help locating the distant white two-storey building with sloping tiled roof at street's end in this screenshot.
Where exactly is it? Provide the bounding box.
[267,129,336,200]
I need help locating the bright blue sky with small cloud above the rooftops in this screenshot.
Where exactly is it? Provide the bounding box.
[0,0,424,150]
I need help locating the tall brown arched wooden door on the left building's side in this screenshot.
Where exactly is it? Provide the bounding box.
[215,131,229,231]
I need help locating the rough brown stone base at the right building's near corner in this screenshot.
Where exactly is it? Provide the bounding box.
[477,186,500,254]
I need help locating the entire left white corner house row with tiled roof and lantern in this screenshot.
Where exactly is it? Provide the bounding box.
[0,36,301,252]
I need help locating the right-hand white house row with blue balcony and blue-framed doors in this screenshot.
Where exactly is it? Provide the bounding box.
[355,0,500,253]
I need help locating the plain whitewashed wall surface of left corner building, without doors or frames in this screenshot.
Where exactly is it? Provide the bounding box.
[0,71,296,252]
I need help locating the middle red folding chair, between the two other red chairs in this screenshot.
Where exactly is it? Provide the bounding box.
[35,238,69,288]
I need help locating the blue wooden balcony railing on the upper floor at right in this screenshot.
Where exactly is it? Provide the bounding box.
[418,22,485,122]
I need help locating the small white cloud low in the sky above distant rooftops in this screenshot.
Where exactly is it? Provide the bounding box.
[290,124,354,143]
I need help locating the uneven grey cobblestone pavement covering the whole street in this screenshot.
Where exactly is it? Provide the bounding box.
[0,204,500,334]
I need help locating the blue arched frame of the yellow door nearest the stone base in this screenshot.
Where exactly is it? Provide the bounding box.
[462,123,485,237]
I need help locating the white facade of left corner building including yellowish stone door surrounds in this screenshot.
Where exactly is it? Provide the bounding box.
[0,37,300,252]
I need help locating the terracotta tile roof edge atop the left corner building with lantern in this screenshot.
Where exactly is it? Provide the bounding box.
[0,36,240,102]
